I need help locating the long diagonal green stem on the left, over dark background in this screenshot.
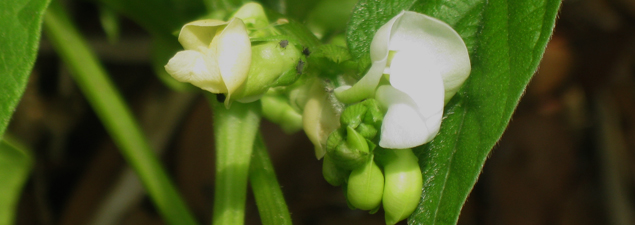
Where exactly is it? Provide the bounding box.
[44,1,196,224]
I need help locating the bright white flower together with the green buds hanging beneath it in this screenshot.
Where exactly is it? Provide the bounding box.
[323,9,471,224]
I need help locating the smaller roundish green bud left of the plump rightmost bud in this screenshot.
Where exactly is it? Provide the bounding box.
[346,157,384,210]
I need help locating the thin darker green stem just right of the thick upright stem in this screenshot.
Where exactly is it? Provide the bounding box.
[249,135,291,225]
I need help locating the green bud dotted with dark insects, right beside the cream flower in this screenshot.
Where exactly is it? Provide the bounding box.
[236,42,301,102]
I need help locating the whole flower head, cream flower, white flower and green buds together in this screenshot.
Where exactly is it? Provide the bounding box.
[165,3,471,224]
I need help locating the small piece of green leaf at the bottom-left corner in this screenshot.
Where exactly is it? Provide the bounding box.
[0,140,33,225]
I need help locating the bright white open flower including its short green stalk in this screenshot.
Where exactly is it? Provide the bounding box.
[335,11,471,149]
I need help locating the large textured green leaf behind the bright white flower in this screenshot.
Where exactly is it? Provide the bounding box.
[347,0,561,224]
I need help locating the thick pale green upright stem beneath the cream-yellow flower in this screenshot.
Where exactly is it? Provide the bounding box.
[208,94,260,225]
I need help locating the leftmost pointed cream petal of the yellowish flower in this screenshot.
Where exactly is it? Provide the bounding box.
[165,50,227,93]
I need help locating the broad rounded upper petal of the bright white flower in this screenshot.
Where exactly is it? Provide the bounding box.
[389,12,471,102]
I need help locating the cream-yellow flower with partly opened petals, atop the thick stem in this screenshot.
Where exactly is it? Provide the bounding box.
[165,18,251,104]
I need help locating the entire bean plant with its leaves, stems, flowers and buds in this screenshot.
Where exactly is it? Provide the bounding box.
[0,0,561,225]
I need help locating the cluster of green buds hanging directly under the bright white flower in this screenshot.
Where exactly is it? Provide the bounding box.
[322,99,423,224]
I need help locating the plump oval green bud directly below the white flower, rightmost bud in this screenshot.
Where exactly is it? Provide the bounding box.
[378,149,423,225]
